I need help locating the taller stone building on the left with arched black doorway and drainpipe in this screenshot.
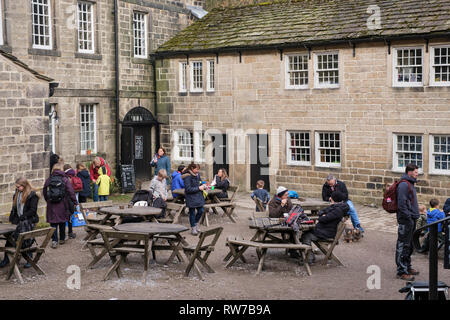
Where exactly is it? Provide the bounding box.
[0,0,201,214]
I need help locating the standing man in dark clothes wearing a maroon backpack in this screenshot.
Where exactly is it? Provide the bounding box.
[395,163,420,281]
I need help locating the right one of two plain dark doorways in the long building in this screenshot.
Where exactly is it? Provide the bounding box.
[249,134,270,191]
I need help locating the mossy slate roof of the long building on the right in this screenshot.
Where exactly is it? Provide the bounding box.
[156,0,450,56]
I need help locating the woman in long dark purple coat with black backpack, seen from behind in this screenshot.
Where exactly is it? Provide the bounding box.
[43,163,78,249]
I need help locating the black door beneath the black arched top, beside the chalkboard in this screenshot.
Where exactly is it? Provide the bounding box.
[132,126,151,180]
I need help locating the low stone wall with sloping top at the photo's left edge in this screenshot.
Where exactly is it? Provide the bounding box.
[0,50,52,213]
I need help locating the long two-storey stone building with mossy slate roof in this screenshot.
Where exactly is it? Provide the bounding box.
[156,0,450,204]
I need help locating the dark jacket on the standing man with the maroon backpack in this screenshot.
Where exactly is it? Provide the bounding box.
[397,174,420,224]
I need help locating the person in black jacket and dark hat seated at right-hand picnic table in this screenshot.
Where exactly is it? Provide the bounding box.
[300,191,350,262]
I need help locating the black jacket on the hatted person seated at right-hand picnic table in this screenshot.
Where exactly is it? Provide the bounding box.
[314,202,350,239]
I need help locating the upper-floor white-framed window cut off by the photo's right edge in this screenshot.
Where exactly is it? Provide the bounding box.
[430,45,450,86]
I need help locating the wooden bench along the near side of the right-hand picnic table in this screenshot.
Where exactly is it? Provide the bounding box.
[226,237,312,275]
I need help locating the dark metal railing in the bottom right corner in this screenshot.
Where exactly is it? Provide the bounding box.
[413,216,450,300]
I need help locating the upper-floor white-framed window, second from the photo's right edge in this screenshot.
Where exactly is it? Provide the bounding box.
[392,47,423,87]
